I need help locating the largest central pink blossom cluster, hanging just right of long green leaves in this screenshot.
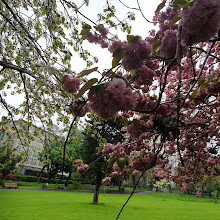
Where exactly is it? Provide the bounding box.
[88,78,138,119]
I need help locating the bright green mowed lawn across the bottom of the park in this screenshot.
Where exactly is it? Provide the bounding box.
[0,190,220,220]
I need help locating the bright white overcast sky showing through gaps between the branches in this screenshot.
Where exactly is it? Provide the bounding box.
[0,0,161,124]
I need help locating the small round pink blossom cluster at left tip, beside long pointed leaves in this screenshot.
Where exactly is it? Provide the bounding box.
[62,75,80,93]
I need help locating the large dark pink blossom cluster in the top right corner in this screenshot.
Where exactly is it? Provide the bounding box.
[180,0,220,46]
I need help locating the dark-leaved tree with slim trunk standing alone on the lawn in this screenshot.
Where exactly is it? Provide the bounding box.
[81,115,123,203]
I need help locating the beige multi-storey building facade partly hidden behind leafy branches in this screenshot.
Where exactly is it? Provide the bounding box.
[0,121,55,175]
